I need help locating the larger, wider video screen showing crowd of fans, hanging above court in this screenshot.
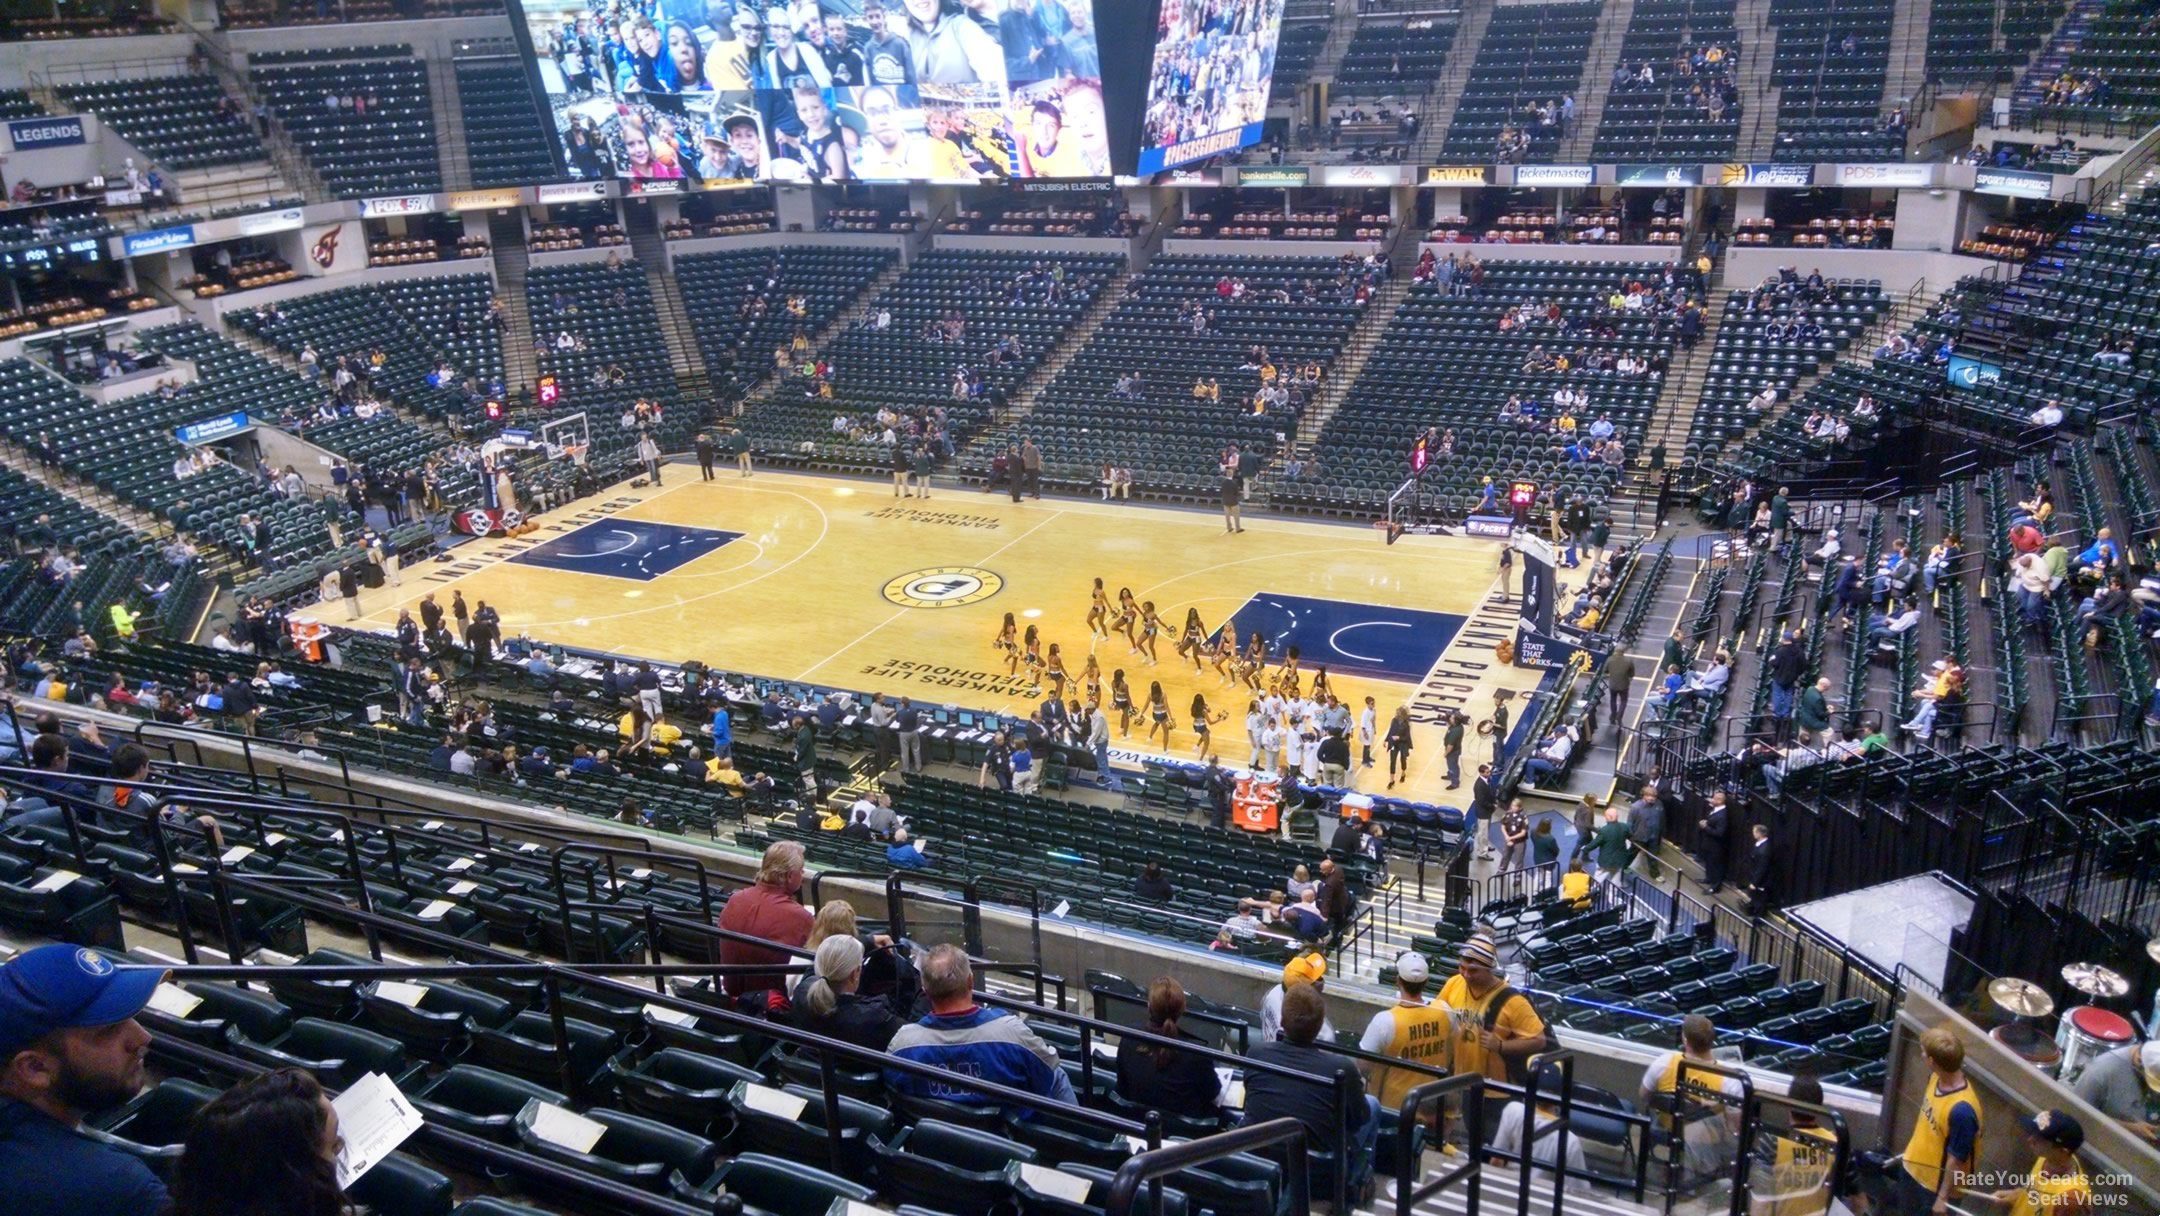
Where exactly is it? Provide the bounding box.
[507,0,1114,188]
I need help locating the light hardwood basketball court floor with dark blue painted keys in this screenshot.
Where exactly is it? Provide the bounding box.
[365,464,1536,801]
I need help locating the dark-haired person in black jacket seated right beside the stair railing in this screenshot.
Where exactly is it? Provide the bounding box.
[1244,985,1380,1203]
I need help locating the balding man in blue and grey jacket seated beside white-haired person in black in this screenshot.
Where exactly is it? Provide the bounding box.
[885,946,1074,1117]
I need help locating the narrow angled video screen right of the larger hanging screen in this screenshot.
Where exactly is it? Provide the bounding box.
[1138,0,1283,175]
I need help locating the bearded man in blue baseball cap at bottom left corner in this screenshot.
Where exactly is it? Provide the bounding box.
[0,946,166,1216]
